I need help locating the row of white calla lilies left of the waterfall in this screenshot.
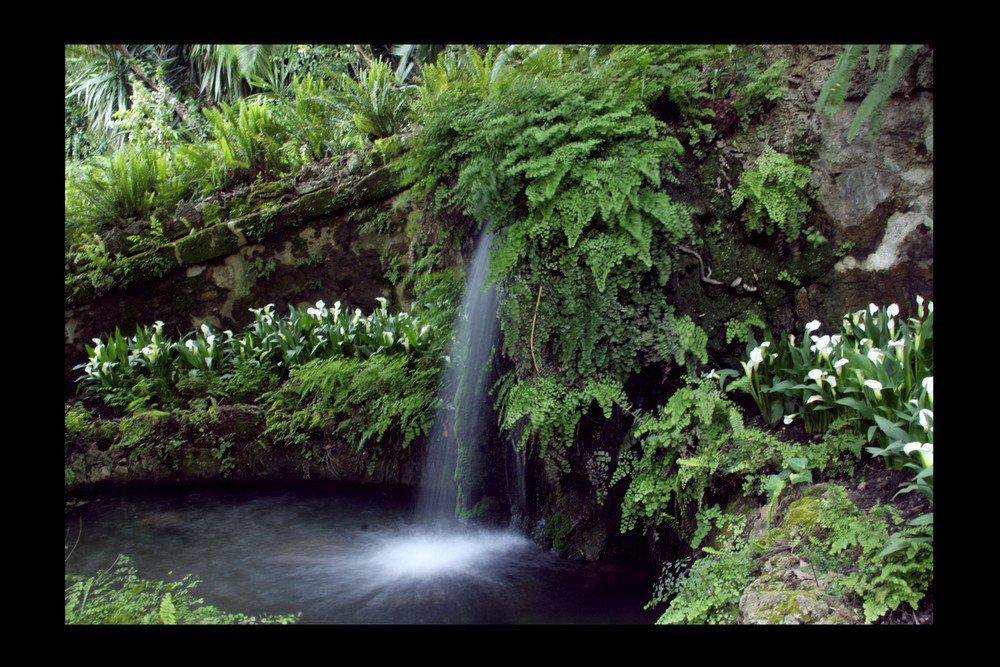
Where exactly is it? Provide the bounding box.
[76,298,442,412]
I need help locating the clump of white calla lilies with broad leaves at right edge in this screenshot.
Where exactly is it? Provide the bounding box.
[734,297,934,501]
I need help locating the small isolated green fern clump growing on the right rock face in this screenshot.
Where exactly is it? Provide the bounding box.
[733,146,812,241]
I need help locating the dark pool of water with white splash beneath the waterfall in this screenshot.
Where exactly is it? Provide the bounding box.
[65,487,657,624]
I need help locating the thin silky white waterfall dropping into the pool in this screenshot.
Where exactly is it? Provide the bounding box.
[417,230,500,523]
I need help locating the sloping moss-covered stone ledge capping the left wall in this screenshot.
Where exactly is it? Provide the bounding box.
[65,165,402,308]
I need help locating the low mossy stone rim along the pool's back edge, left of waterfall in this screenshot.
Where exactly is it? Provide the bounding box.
[65,404,423,495]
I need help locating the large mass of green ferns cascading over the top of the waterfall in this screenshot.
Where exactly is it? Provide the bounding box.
[405,48,716,392]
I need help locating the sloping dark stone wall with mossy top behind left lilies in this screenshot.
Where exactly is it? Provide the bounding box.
[65,161,410,393]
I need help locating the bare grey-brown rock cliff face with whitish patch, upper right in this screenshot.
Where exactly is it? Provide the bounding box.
[703,45,934,333]
